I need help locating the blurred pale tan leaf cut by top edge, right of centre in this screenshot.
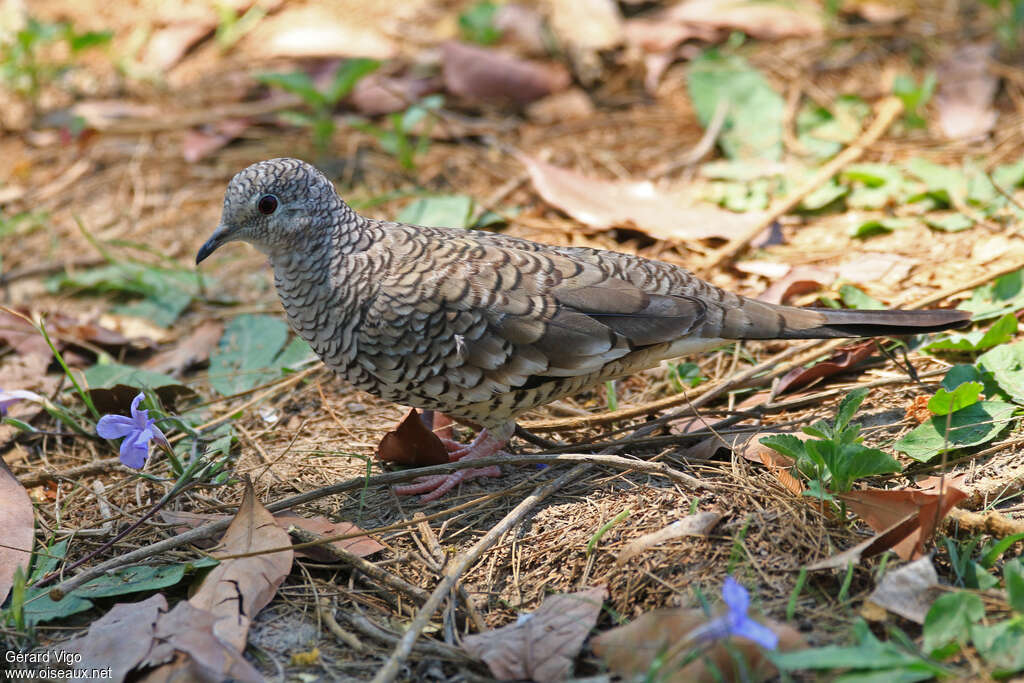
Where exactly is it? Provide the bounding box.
[657,0,825,40]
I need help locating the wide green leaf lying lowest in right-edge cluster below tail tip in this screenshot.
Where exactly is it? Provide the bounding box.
[893,400,1016,463]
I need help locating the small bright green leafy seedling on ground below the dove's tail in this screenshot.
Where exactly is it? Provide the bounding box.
[761,389,900,500]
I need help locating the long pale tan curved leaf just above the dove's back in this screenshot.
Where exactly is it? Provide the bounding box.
[519,156,760,242]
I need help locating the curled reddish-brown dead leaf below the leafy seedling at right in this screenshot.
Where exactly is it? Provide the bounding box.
[838,478,967,560]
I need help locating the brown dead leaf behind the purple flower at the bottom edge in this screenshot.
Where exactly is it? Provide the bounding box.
[591,608,807,683]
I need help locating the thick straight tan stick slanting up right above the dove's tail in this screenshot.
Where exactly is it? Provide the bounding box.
[701,97,903,272]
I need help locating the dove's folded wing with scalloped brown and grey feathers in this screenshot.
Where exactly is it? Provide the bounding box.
[357,236,707,402]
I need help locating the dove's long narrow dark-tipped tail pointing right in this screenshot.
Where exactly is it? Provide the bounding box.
[719,299,971,339]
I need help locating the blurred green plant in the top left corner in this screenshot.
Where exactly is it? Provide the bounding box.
[0,17,114,106]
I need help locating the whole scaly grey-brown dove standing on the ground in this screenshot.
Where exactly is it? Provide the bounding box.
[196,159,970,500]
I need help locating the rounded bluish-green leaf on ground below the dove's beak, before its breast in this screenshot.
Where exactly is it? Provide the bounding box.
[210,315,288,396]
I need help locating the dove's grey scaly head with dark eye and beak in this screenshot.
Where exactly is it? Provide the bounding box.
[196,159,344,263]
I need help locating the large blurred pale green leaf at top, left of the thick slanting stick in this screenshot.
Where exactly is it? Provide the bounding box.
[687,50,785,160]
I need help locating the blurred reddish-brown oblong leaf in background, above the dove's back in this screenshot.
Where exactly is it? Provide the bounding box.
[441,41,571,105]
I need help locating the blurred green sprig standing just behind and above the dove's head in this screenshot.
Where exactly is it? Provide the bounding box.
[256,58,380,155]
